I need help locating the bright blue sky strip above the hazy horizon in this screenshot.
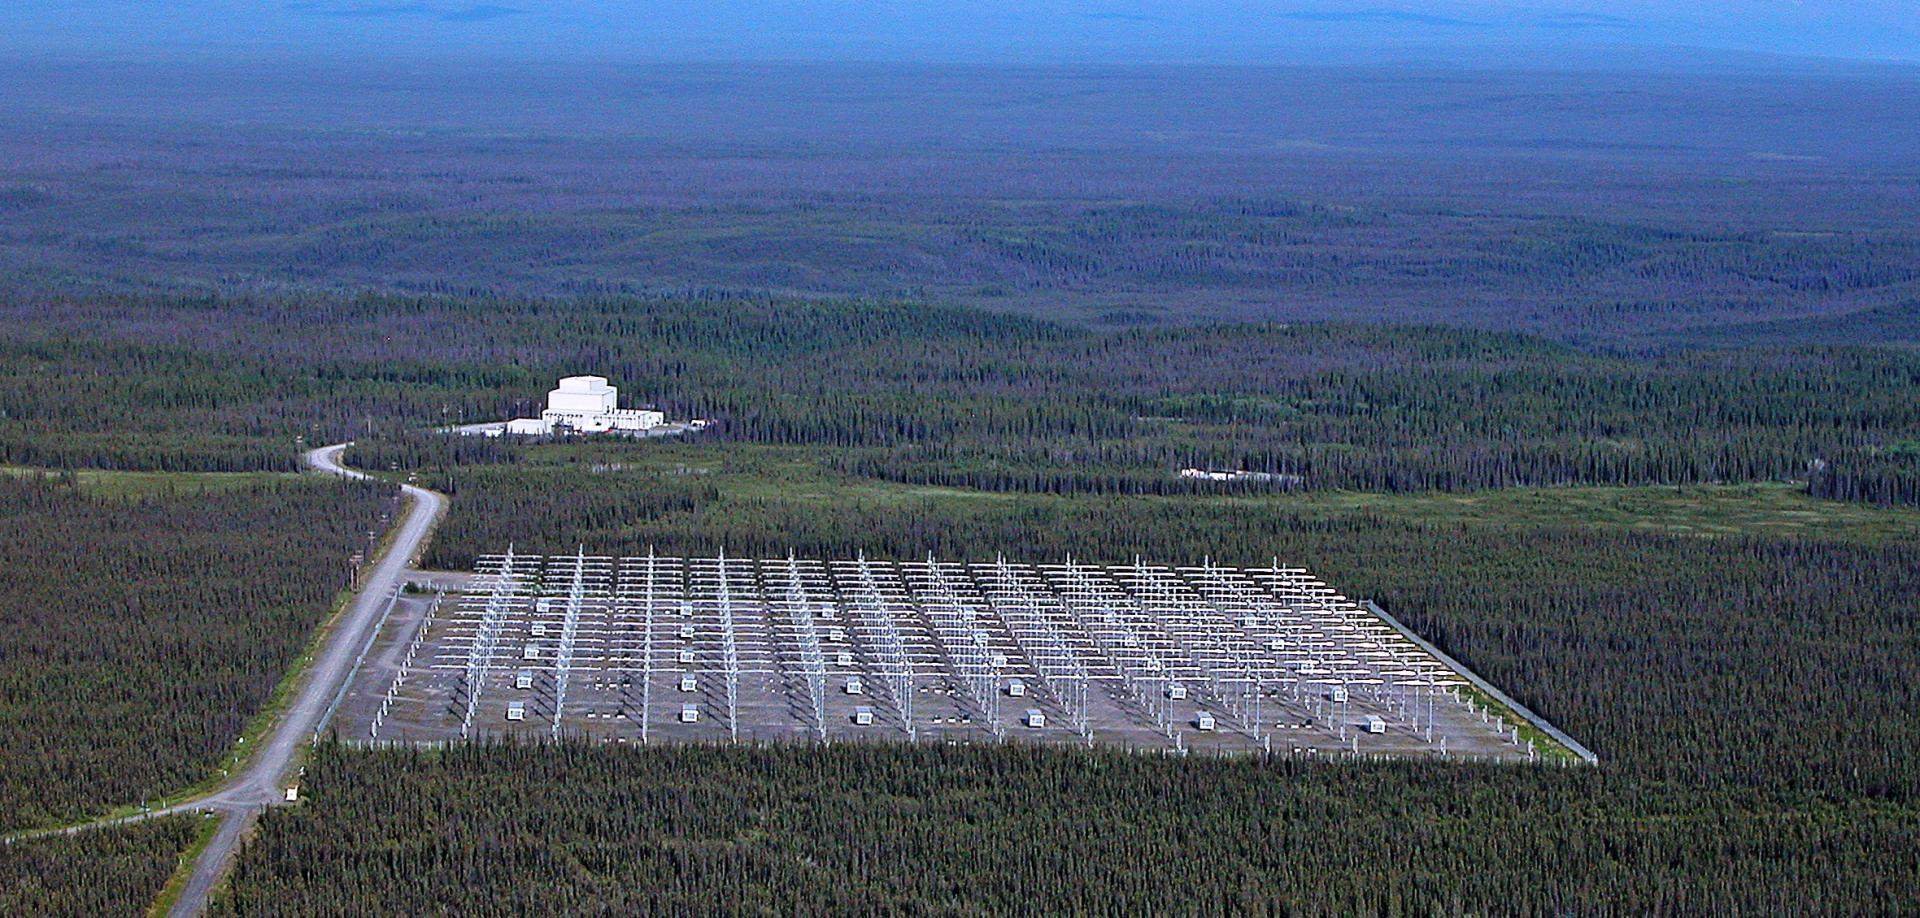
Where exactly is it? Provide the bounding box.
[0,0,1920,63]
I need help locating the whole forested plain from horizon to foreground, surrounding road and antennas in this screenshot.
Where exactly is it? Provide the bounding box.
[0,57,1920,916]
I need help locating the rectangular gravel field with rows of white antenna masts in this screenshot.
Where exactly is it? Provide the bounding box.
[340,551,1582,761]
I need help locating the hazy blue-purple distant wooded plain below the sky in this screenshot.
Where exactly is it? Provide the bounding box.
[0,58,1920,342]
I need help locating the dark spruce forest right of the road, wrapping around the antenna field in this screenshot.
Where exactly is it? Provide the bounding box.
[210,483,1920,914]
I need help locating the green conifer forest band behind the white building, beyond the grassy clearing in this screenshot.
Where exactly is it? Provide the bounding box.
[0,298,1920,501]
